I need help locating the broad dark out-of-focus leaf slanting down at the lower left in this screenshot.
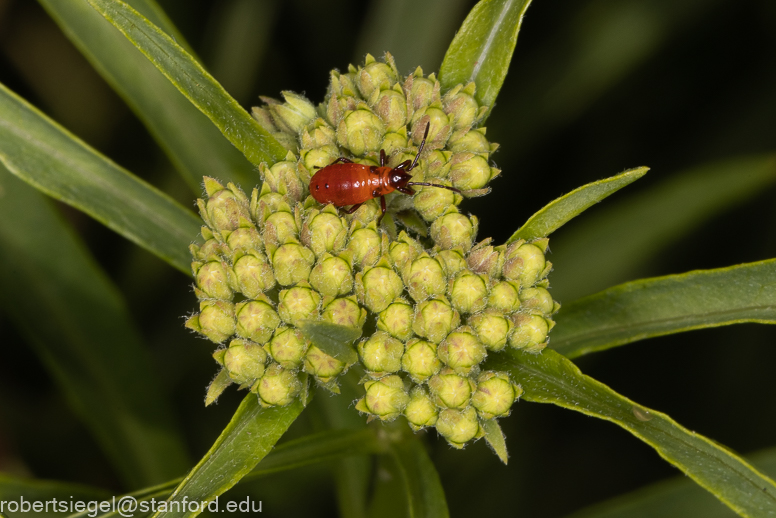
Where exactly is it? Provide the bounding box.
[0,170,188,486]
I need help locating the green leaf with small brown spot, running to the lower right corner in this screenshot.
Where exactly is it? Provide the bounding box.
[490,350,776,517]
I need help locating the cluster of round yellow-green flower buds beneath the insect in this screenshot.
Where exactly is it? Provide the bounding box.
[186,55,558,447]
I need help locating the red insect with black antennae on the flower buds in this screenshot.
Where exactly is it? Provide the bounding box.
[310,128,461,223]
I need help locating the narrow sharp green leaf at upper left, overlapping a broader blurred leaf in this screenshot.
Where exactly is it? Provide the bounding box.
[89,0,287,170]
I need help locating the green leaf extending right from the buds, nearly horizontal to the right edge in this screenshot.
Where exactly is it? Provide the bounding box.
[550,259,776,358]
